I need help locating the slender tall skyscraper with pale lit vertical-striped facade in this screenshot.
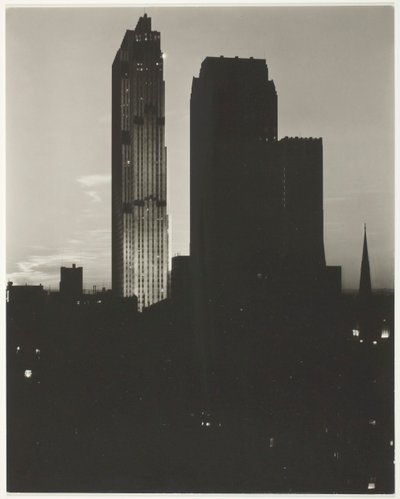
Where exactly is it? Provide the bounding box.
[112,14,168,310]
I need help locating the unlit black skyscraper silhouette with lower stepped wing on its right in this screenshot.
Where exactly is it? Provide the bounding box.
[190,57,334,328]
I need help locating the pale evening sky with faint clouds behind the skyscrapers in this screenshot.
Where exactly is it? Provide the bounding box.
[6,6,394,290]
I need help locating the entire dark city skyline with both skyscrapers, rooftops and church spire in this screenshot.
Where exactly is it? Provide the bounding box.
[7,15,394,493]
